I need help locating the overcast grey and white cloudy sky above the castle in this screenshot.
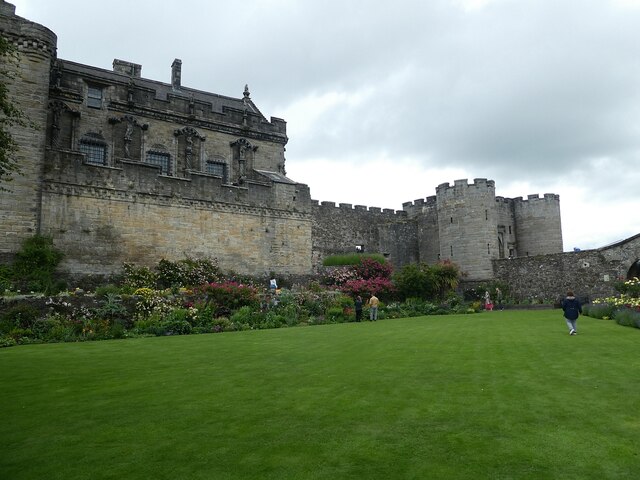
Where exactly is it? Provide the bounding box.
[11,0,640,250]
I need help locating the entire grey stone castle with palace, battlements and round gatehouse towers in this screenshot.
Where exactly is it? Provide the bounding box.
[0,1,562,280]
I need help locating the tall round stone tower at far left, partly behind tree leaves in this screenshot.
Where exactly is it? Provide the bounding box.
[0,0,57,260]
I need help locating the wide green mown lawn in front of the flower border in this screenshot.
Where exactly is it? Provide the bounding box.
[0,310,640,480]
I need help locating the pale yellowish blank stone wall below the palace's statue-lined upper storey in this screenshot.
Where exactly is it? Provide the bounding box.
[42,151,312,276]
